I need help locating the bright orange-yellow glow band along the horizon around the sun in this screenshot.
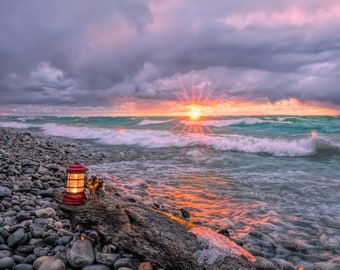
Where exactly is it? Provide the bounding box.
[115,98,340,117]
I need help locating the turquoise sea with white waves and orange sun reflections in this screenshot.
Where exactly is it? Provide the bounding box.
[0,116,340,269]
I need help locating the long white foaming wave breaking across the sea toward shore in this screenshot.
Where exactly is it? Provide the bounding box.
[0,118,340,157]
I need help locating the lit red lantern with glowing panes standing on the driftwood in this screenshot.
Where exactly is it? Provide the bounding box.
[63,164,87,205]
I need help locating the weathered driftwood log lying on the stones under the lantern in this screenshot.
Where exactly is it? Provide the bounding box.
[60,181,254,270]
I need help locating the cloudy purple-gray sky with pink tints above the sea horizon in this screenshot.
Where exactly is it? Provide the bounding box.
[0,0,340,115]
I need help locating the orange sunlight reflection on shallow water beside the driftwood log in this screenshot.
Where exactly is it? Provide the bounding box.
[104,173,278,237]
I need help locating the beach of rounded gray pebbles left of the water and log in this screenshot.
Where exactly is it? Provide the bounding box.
[0,128,255,270]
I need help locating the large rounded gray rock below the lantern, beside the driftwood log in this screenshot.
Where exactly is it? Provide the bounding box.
[66,239,94,268]
